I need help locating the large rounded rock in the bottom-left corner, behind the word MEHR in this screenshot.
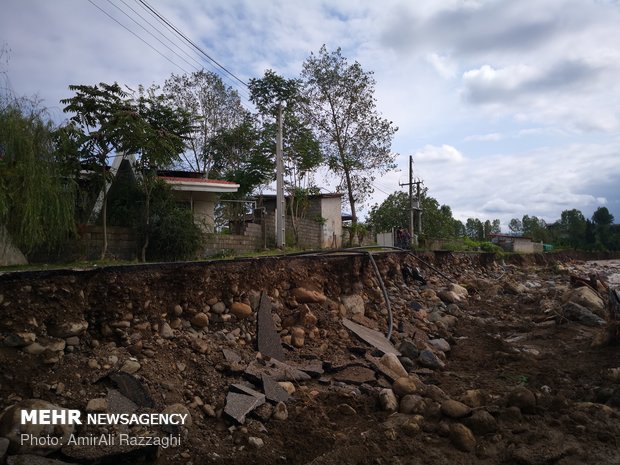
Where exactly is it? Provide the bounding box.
[0,399,75,455]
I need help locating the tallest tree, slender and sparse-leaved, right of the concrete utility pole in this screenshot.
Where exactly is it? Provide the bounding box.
[301,45,398,228]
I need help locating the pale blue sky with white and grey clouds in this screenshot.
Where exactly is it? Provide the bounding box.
[0,0,620,228]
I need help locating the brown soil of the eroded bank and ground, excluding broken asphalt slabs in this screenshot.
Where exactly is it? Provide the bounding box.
[0,253,620,465]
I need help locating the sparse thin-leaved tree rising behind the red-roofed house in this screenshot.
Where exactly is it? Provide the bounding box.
[163,70,248,177]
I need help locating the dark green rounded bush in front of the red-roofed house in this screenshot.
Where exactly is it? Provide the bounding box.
[140,181,204,261]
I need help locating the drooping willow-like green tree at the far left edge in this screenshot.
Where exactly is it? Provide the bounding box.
[0,100,75,253]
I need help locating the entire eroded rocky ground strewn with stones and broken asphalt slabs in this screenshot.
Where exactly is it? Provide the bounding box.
[0,253,620,465]
